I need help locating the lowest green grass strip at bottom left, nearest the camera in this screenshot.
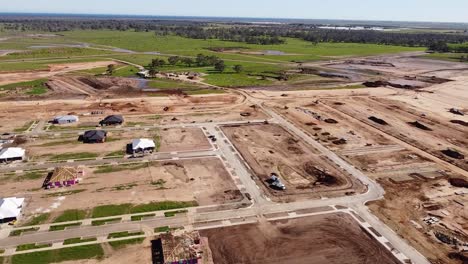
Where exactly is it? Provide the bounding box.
[11,244,104,264]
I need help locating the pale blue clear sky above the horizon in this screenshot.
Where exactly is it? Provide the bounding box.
[0,0,468,22]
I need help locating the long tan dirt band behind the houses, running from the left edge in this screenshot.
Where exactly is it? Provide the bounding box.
[0,94,245,133]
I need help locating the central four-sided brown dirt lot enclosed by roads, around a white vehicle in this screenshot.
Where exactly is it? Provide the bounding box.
[222,124,363,201]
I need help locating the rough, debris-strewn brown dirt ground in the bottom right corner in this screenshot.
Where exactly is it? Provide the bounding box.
[369,179,468,264]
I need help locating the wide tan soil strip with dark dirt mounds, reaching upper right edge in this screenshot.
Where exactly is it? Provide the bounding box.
[324,97,468,170]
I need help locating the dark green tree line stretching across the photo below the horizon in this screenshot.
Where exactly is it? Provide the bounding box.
[0,17,468,47]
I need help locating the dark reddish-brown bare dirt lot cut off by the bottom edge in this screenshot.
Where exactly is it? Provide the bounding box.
[200,214,399,264]
